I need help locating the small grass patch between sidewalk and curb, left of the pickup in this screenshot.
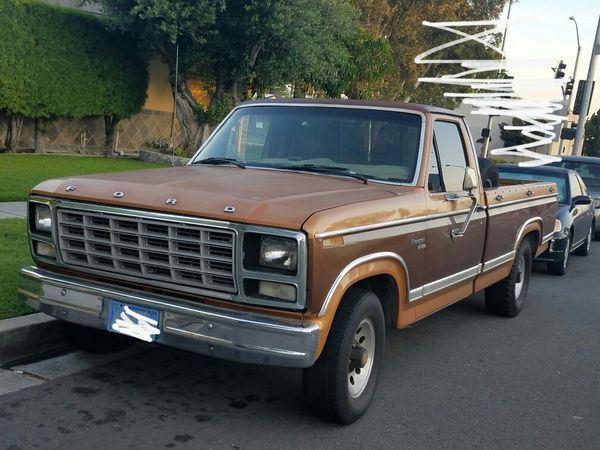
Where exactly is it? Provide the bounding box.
[0,219,33,319]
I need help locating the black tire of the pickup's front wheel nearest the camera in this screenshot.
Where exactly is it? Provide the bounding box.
[303,289,385,424]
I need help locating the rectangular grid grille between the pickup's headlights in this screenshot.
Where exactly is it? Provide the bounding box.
[57,208,236,292]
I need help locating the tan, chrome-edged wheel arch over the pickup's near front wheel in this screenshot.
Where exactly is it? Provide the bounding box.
[309,252,414,357]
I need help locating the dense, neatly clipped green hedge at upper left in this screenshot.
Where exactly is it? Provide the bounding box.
[0,0,148,118]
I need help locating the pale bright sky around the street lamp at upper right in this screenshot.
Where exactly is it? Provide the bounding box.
[503,0,600,118]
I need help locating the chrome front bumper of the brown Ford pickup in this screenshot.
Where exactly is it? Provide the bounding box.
[17,266,319,367]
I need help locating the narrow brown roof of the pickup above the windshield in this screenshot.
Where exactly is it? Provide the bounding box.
[240,98,464,117]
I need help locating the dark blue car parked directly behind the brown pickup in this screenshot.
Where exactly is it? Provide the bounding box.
[498,164,595,275]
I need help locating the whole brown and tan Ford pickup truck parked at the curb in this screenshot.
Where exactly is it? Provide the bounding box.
[19,100,556,423]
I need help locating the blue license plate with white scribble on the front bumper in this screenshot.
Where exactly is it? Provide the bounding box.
[107,301,160,342]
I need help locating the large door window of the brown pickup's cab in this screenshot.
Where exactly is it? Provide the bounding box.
[433,121,467,192]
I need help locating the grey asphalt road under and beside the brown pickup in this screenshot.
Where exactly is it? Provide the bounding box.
[0,242,600,450]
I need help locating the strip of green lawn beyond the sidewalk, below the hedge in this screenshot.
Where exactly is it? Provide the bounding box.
[0,153,163,202]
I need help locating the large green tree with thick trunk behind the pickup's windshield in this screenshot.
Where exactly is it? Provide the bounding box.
[97,0,366,148]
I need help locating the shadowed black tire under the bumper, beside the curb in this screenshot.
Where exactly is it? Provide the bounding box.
[63,322,134,355]
